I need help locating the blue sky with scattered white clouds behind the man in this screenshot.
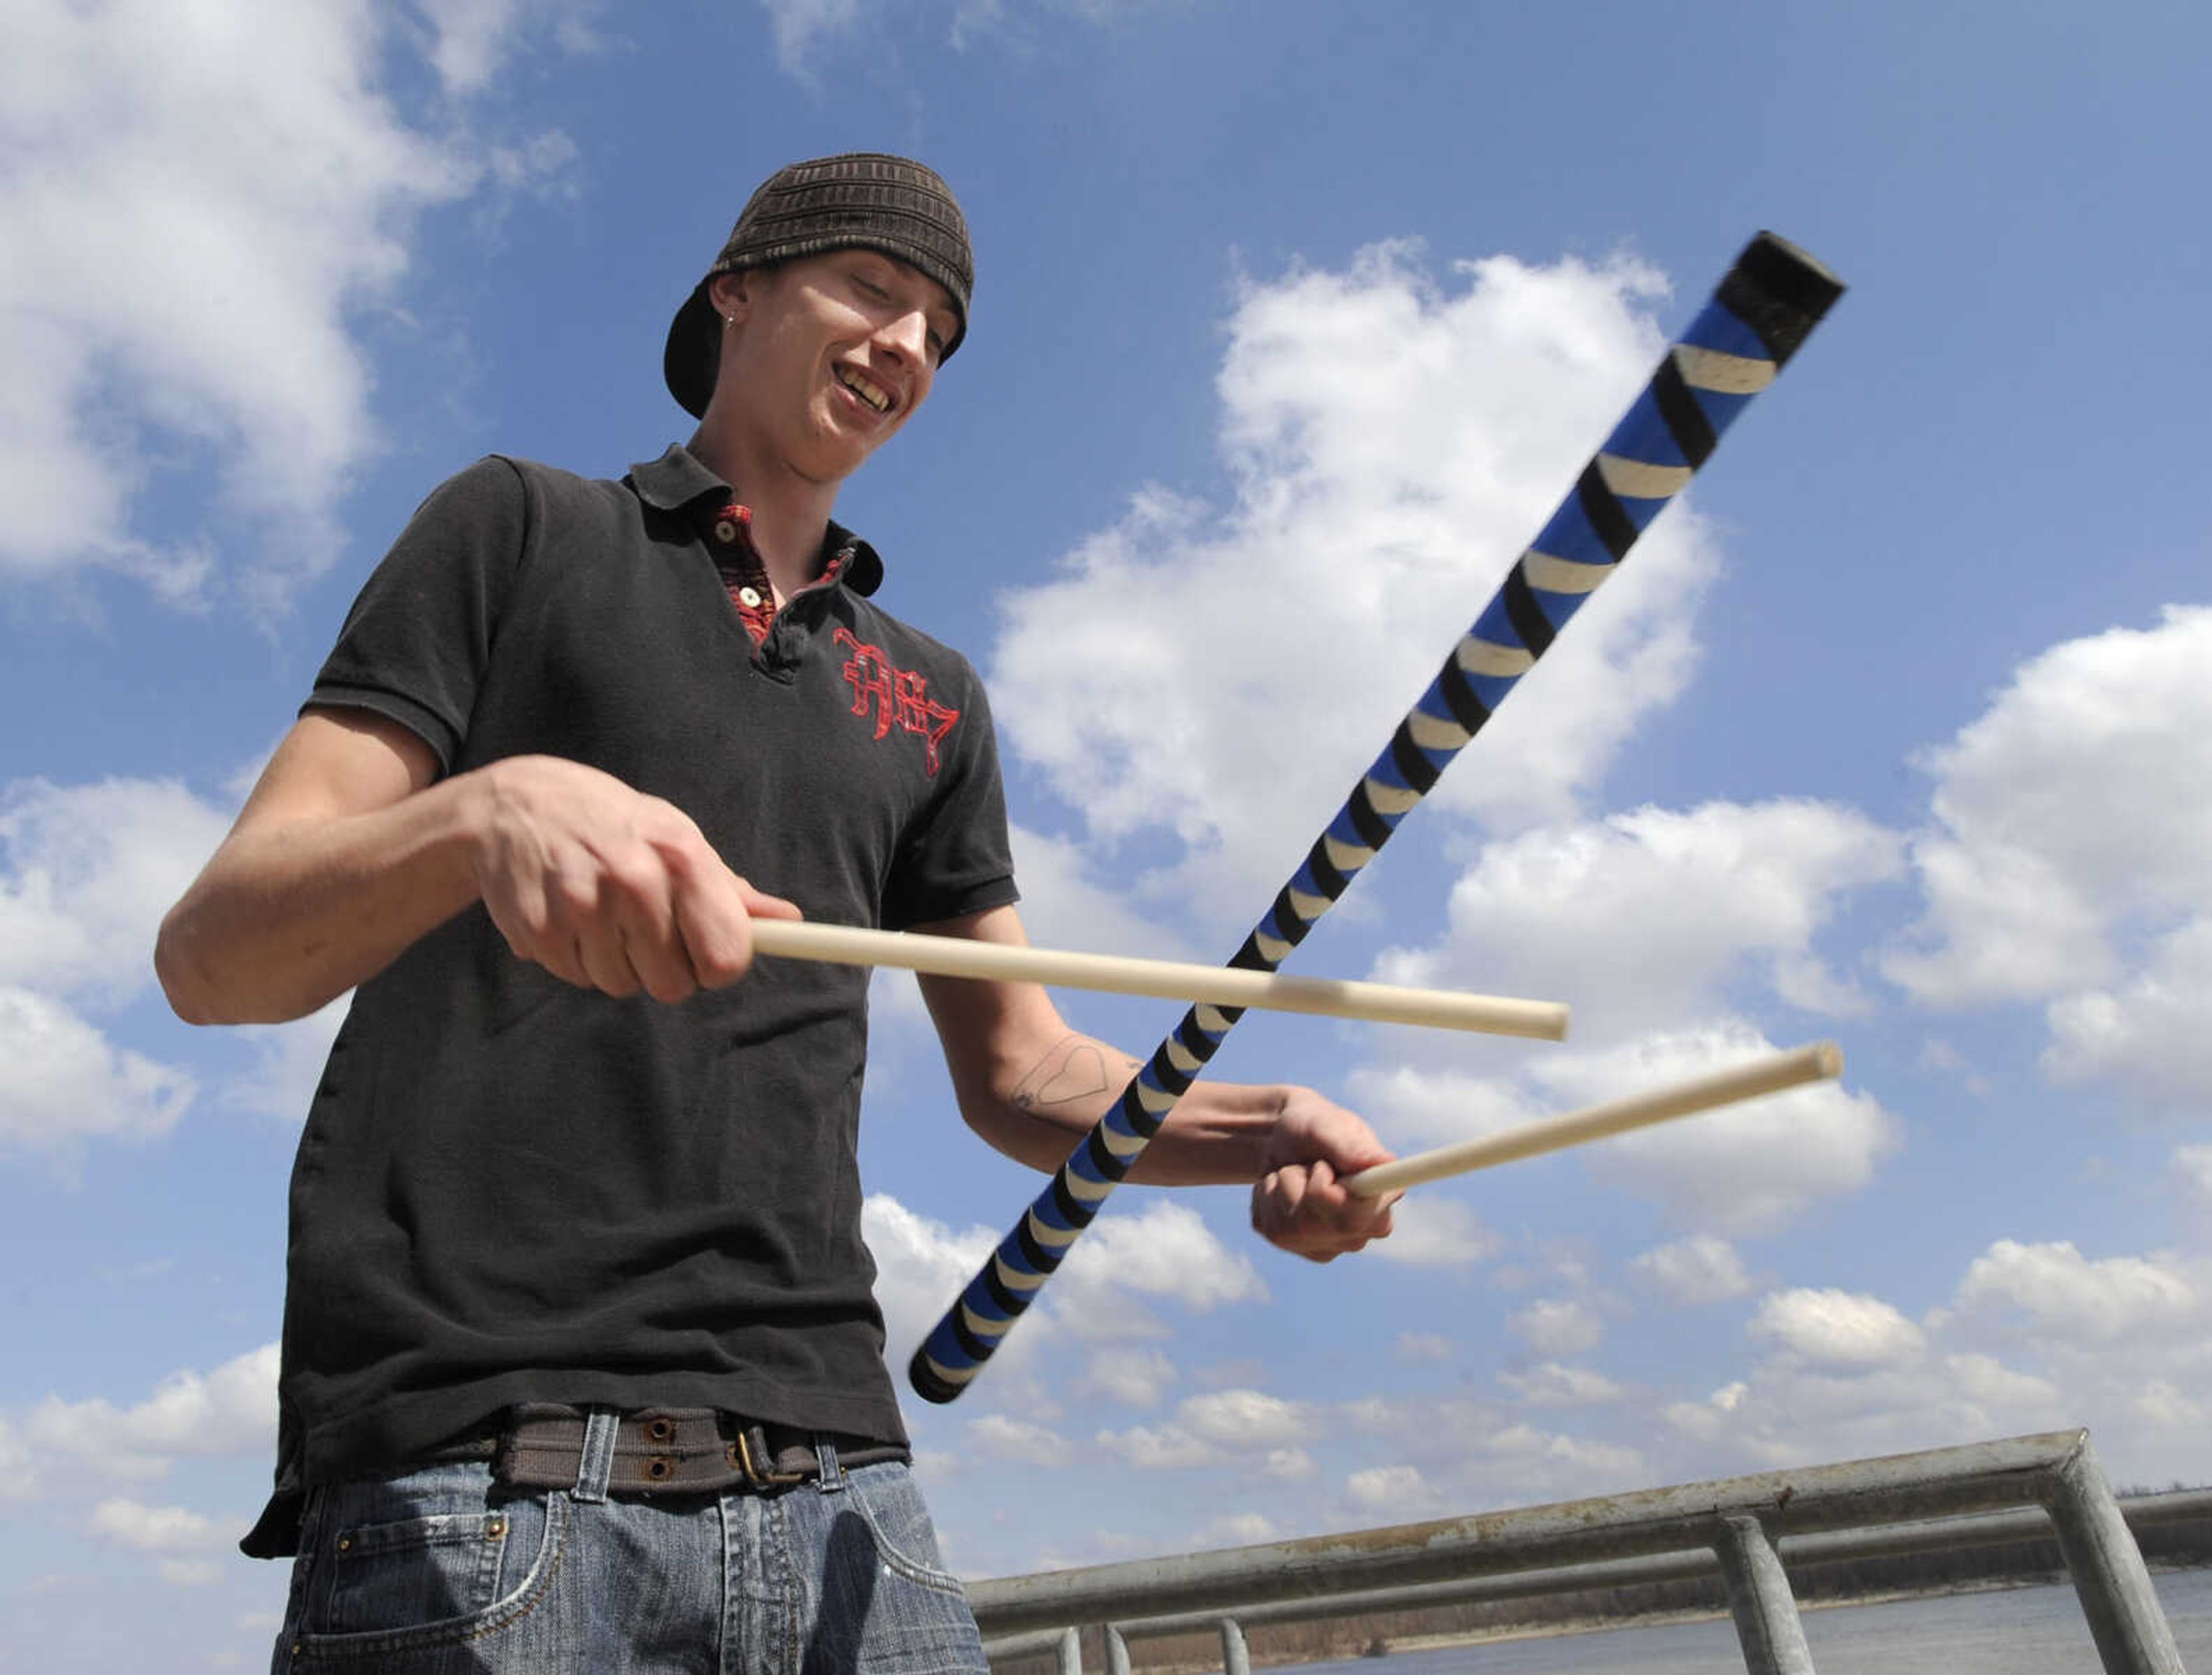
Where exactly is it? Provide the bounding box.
[0,0,2212,1670]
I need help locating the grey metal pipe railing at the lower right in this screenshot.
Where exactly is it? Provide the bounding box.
[969,1430,2212,1675]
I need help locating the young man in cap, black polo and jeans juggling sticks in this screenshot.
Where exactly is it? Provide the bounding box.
[157,155,1389,1675]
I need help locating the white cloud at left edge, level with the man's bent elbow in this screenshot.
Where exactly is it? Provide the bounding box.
[0,779,230,1003]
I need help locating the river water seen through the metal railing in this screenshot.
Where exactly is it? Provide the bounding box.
[1309,1569,2212,1675]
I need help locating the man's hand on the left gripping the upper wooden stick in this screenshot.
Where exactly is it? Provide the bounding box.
[474,757,798,1003]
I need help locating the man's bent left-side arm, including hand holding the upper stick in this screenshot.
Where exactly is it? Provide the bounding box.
[155,708,798,1024]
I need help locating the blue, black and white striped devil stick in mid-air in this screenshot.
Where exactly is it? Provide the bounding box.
[907,222,1843,1403]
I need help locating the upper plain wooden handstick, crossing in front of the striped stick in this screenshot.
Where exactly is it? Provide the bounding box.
[752,918,1566,1040]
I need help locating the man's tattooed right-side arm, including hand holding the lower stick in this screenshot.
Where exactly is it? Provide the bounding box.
[920,907,1396,1261]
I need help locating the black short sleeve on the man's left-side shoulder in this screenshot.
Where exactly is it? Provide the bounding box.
[303,456,529,772]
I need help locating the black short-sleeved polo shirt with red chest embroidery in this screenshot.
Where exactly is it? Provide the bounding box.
[255,449,1016,1551]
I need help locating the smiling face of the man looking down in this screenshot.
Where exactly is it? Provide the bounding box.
[710,250,960,482]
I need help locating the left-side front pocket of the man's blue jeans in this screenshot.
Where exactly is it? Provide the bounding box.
[298,1467,566,1655]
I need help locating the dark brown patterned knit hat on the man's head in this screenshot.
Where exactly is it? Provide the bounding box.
[661,150,975,418]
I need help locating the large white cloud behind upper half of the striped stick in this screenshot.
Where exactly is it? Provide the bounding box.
[991,245,1717,914]
